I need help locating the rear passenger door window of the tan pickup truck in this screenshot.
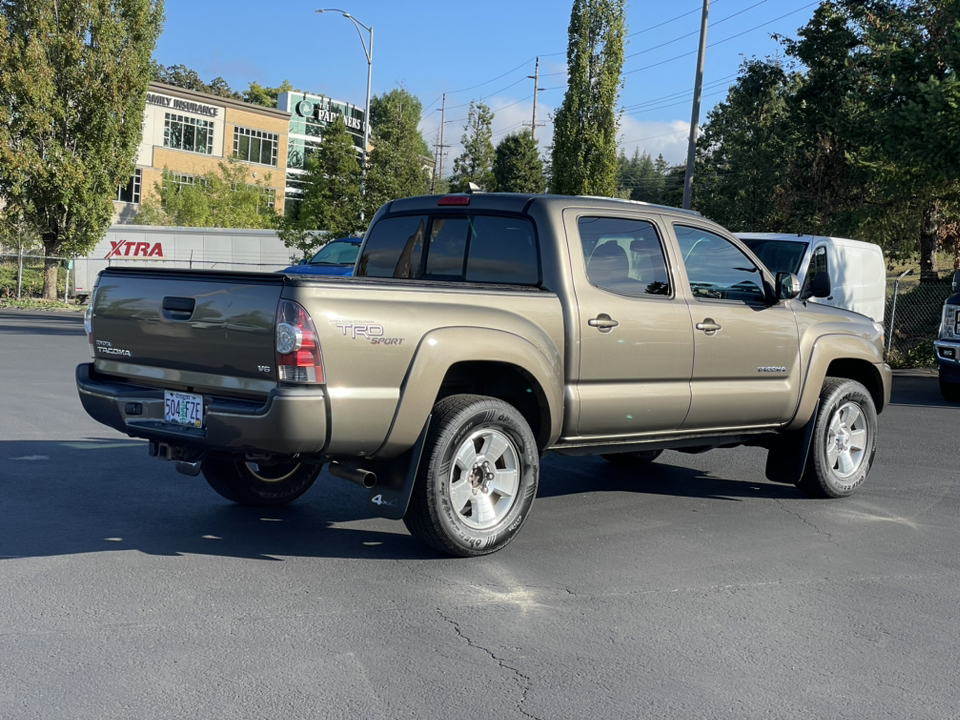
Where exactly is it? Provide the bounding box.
[577,217,671,295]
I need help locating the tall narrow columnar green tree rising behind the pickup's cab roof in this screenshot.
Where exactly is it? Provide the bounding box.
[551,0,625,196]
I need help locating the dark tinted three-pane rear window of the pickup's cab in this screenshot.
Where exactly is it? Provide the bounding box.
[356,213,541,286]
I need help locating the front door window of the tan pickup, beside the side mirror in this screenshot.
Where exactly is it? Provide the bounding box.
[674,225,766,302]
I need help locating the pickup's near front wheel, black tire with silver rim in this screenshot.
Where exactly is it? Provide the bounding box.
[797,378,877,498]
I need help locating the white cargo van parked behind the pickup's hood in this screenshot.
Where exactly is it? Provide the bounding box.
[736,233,887,324]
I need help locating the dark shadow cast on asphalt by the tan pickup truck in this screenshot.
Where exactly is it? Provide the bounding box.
[0,438,802,562]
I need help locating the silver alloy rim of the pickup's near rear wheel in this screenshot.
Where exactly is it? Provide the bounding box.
[449,428,520,530]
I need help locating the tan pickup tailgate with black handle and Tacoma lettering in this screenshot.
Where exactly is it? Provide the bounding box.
[93,268,284,391]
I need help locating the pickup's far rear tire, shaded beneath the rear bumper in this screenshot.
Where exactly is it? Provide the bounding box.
[200,458,321,507]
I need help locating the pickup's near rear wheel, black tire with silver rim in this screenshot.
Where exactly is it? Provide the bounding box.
[403,395,540,557]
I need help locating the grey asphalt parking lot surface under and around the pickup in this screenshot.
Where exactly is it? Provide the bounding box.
[0,310,960,720]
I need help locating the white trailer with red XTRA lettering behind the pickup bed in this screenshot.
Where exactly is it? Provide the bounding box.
[73,225,296,300]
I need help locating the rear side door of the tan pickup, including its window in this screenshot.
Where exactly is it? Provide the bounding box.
[564,209,693,438]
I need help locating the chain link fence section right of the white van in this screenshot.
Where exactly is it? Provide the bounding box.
[884,277,952,368]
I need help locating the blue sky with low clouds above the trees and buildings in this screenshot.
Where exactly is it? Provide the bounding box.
[154,0,819,166]
